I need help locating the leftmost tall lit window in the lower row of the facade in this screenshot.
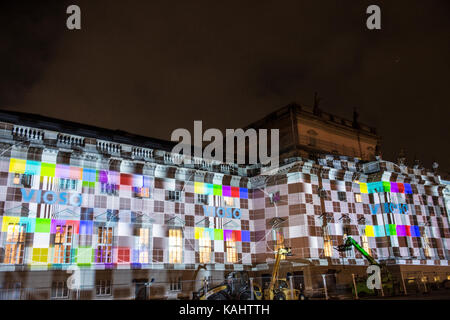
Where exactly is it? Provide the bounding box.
[3,223,26,264]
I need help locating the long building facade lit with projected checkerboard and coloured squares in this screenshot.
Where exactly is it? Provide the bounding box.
[0,108,450,299]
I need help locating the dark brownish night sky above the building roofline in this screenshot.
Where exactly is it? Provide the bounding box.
[0,0,450,175]
